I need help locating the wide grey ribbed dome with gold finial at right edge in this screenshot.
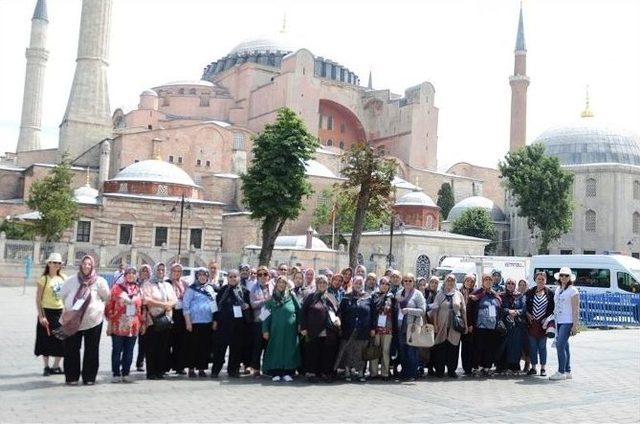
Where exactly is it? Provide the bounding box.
[534,118,640,165]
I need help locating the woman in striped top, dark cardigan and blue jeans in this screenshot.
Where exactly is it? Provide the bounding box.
[526,272,554,377]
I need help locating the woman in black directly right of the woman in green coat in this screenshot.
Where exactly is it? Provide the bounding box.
[300,275,340,383]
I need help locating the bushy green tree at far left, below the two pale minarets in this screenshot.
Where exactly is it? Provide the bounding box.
[27,155,78,241]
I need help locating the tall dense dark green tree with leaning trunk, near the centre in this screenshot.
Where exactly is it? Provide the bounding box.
[242,108,319,266]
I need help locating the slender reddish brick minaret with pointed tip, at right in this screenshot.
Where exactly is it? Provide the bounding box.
[509,5,529,152]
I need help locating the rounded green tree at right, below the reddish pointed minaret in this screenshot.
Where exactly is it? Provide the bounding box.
[498,144,573,253]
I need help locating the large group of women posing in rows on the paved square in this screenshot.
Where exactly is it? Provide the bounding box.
[35,253,579,385]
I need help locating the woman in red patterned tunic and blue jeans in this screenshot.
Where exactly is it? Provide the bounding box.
[104,267,145,383]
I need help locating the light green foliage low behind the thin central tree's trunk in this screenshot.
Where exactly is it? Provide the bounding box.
[313,187,391,233]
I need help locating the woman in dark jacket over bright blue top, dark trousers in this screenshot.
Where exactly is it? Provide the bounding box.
[467,274,502,376]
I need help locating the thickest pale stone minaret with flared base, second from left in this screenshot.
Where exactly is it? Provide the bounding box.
[59,0,113,160]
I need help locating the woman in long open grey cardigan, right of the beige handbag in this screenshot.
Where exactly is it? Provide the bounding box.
[433,274,467,378]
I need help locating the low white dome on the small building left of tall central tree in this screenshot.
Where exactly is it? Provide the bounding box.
[110,159,198,187]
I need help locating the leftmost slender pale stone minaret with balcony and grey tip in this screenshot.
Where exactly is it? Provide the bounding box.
[16,0,49,152]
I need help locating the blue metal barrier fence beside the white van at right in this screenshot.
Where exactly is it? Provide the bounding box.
[580,291,640,327]
